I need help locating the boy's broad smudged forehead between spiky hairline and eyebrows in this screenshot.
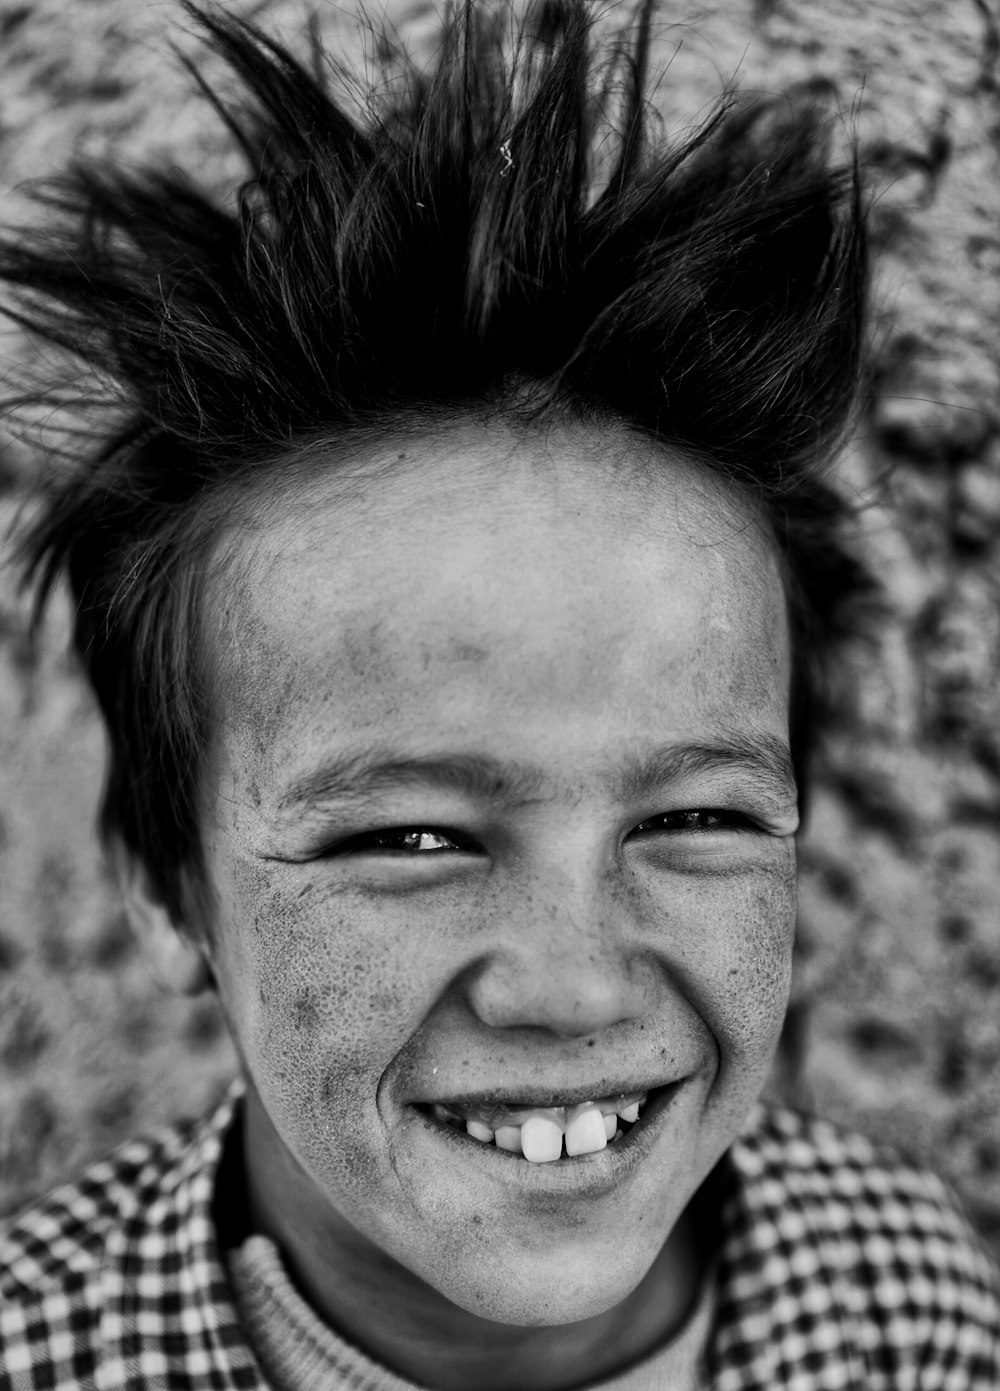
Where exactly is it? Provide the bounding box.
[209,411,787,784]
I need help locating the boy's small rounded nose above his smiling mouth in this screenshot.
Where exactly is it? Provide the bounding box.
[467,882,652,1038]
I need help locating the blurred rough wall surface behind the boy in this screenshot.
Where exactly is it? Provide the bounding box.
[0,0,1000,1252]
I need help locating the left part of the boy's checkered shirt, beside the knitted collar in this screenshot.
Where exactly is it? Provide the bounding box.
[0,1099,253,1391]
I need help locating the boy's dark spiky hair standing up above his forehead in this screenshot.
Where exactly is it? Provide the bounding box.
[0,0,866,921]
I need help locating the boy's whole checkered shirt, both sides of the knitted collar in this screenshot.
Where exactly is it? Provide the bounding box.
[0,1091,1000,1391]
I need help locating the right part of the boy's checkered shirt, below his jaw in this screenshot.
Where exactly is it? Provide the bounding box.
[723,1106,1000,1391]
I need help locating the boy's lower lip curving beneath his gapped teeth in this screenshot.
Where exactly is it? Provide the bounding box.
[412,1082,683,1196]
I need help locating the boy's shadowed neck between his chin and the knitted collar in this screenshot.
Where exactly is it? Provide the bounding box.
[235,1097,704,1391]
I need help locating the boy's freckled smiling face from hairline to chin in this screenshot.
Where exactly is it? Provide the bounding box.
[198,424,797,1324]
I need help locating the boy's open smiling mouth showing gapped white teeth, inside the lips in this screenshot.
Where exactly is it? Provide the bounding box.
[420,1088,669,1164]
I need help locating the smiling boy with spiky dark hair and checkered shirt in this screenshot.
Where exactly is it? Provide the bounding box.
[0,0,1000,1391]
